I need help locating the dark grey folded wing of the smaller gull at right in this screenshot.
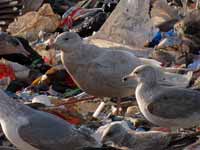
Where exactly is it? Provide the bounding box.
[147,88,200,119]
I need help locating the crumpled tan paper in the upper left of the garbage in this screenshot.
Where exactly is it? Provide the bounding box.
[7,4,60,41]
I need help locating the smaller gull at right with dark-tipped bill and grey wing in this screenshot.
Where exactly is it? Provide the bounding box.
[124,65,200,127]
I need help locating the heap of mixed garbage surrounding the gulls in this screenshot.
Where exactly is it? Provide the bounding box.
[0,0,200,150]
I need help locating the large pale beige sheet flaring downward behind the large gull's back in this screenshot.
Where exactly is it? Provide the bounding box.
[94,0,157,48]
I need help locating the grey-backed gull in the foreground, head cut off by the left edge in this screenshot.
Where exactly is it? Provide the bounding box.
[0,90,100,150]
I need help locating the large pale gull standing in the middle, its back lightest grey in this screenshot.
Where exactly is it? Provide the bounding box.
[55,32,191,98]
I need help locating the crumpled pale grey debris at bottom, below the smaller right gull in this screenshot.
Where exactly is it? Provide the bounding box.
[95,122,173,150]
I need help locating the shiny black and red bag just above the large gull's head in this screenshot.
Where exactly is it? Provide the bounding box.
[61,7,107,37]
